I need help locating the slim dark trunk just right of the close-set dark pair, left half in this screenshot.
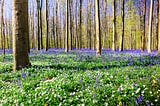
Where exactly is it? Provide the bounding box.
[46,0,49,51]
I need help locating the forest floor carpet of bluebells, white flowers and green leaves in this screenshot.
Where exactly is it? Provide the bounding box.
[0,49,160,106]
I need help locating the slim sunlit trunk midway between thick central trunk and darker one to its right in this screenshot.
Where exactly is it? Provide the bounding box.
[112,0,116,51]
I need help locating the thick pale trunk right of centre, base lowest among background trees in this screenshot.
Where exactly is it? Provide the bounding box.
[95,0,101,56]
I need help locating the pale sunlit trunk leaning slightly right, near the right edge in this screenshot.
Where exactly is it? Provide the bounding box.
[147,0,154,53]
